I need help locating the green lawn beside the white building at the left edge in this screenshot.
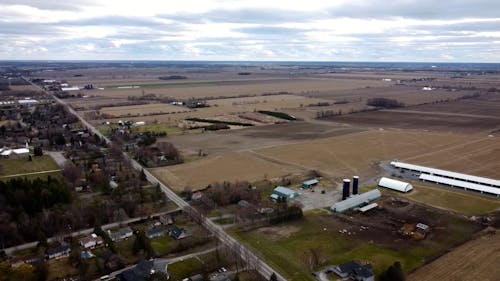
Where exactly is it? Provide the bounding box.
[0,155,59,177]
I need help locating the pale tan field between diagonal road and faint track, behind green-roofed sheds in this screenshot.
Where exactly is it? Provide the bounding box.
[151,152,294,191]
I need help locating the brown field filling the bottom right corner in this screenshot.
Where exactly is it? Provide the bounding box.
[408,231,500,281]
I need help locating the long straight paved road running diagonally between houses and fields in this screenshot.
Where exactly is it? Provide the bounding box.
[22,77,286,281]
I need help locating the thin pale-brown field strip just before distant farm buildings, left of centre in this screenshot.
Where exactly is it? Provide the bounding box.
[100,103,190,116]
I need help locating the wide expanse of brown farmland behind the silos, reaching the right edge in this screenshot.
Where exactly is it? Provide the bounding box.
[156,129,500,190]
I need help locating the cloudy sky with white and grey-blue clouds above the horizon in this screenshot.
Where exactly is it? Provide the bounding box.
[0,0,500,62]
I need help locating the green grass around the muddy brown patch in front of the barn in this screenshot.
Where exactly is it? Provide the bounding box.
[230,212,477,280]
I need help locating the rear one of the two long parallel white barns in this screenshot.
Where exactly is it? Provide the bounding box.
[391,161,500,188]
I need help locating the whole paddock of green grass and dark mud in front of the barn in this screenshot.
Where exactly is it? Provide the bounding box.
[231,197,480,280]
